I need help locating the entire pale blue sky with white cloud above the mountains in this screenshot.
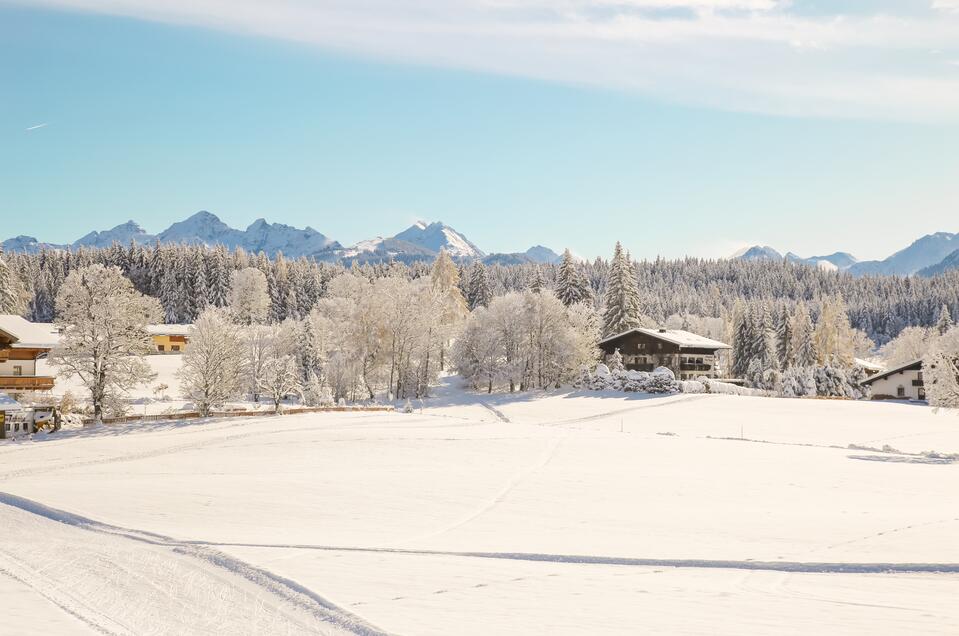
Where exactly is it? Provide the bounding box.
[0,0,959,259]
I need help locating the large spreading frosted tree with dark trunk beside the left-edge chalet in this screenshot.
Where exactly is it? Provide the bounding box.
[50,265,161,421]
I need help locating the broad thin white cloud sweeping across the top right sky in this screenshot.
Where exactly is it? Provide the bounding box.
[16,0,959,121]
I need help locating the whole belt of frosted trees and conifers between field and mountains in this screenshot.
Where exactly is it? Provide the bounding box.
[0,243,959,416]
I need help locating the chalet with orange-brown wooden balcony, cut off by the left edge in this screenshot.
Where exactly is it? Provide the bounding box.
[0,314,60,393]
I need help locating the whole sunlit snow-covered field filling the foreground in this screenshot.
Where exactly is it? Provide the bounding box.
[0,386,959,635]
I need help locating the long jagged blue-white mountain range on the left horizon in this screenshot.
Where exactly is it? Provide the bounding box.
[2,211,560,264]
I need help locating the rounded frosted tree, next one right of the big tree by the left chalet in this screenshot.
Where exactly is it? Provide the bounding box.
[177,309,247,415]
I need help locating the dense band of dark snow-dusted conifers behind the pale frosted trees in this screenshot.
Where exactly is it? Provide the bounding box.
[0,245,959,345]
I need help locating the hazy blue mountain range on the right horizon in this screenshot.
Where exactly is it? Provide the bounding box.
[733,232,959,276]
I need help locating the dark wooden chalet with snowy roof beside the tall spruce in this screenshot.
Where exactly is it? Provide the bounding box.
[599,328,731,380]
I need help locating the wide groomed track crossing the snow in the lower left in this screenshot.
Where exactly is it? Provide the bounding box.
[0,493,394,636]
